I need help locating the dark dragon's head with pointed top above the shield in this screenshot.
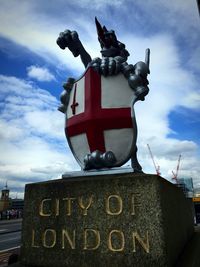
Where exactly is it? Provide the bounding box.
[95,17,129,60]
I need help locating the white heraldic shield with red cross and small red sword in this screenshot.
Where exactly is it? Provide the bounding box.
[65,67,137,169]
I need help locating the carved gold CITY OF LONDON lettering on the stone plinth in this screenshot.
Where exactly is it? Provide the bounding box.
[30,193,151,253]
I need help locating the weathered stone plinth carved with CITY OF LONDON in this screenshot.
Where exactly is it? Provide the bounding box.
[20,173,193,267]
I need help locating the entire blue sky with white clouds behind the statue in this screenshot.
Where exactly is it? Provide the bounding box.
[0,0,200,197]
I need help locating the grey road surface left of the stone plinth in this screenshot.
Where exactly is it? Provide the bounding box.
[0,219,22,267]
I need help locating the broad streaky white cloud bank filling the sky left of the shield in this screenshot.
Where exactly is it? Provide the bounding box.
[0,75,78,198]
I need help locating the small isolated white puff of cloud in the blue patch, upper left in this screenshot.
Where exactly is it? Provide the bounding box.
[27,65,55,82]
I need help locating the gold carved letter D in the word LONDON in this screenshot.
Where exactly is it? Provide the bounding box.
[83,229,101,250]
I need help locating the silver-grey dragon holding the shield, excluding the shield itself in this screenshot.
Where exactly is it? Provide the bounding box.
[57,17,150,172]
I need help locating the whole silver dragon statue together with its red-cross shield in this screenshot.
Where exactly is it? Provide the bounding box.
[57,18,150,172]
